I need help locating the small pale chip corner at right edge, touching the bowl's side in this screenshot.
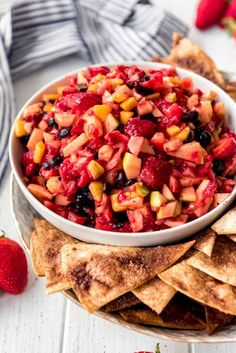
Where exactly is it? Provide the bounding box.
[211,207,236,235]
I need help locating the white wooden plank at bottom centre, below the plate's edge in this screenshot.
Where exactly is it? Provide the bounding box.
[62,302,188,353]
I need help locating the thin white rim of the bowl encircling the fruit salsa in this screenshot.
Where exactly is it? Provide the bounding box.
[9,61,236,239]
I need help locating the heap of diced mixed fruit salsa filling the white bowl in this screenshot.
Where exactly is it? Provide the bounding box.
[15,65,236,232]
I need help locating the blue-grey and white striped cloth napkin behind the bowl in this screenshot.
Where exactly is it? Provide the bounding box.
[0,0,187,181]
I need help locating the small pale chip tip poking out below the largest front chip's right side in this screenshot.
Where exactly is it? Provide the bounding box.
[133,277,176,314]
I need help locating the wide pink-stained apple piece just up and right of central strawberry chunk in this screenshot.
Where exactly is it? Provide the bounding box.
[166,140,204,164]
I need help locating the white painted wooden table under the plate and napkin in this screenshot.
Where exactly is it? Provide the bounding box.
[0,0,236,353]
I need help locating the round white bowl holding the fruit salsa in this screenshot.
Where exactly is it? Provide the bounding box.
[9,62,236,246]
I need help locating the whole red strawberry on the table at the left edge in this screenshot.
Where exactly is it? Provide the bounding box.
[0,238,28,294]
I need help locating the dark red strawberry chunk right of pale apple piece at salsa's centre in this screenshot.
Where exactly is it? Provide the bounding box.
[139,157,172,190]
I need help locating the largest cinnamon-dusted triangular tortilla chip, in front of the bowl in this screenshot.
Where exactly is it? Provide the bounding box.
[61,241,194,312]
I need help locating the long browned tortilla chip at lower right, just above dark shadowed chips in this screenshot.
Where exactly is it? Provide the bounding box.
[158,261,236,315]
